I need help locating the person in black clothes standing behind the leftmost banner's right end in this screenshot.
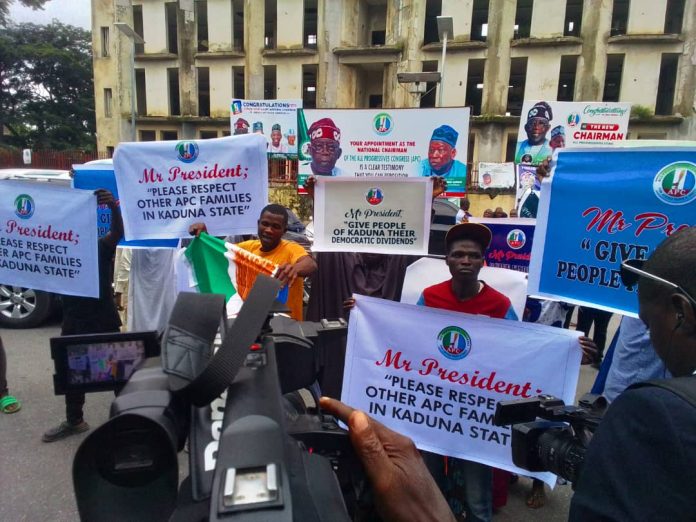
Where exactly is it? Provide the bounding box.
[42,189,123,442]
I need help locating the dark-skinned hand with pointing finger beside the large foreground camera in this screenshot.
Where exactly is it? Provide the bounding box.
[321,397,455,522]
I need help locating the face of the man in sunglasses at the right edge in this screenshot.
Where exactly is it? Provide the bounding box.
[638,287,696,377]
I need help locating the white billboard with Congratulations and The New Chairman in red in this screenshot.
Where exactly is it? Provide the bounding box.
[515,100,631,165]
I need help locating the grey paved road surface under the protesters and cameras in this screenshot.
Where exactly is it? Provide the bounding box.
[0,316,596,522]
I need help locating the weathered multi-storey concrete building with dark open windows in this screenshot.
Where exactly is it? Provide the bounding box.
[92,0,696,165]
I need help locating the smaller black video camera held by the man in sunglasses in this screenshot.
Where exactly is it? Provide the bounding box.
[493,393,607,483]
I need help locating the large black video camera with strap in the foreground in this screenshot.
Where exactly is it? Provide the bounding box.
[59,276,353,522]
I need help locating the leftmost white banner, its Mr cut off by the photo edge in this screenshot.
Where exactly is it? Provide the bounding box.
[0,181,99,297]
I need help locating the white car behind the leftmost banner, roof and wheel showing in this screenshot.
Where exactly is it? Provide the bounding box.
[0,168,70,328]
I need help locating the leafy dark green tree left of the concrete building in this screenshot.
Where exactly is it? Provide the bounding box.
[0,20,95,149]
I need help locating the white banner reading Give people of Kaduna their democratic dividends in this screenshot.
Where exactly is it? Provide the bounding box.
[312,177,433,255]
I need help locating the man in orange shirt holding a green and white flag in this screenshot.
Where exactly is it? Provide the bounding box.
[189,204,317,321]
